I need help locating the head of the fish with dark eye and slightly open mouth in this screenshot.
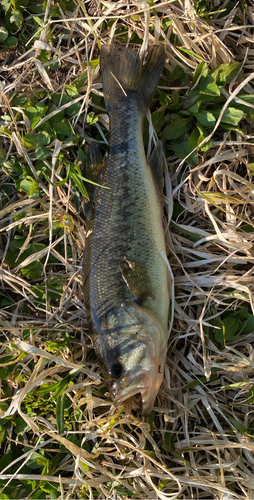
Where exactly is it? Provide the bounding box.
[98,303,167,415]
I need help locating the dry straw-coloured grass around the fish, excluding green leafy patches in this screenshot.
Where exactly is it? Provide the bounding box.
[0,0,254,500]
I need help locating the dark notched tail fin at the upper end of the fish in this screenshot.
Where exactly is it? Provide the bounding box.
[101,45,165,113]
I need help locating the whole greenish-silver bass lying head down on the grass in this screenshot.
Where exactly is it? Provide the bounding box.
[83,44,171,416]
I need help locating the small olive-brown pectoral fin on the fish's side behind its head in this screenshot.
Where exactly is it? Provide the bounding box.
[120,257,154,305]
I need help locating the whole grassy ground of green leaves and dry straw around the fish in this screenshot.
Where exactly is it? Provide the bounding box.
[0,0,254,499]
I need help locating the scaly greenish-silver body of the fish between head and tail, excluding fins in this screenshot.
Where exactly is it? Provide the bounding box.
[86,99,167,319]
